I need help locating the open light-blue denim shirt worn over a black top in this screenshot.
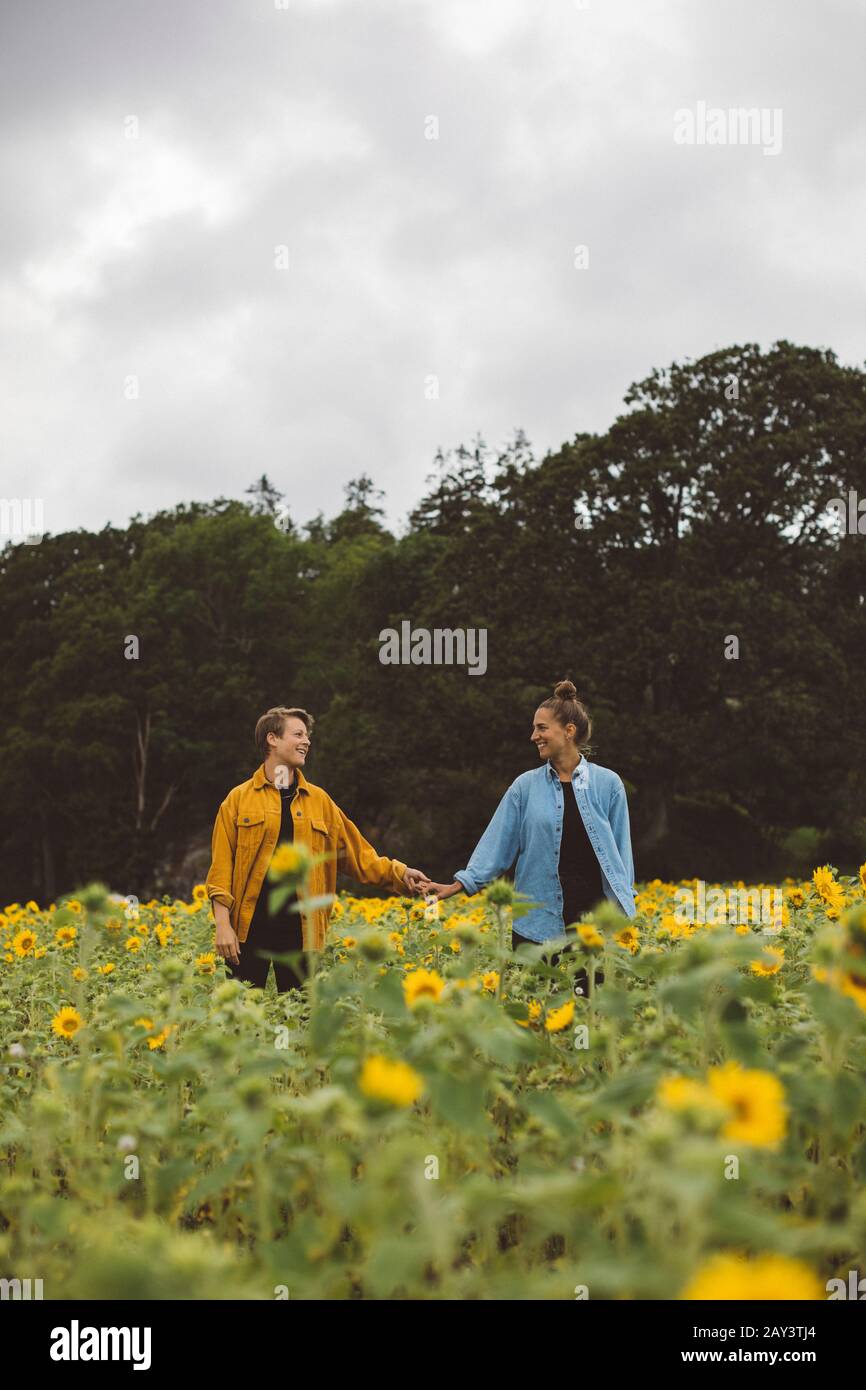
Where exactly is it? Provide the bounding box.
[455,756,635,941]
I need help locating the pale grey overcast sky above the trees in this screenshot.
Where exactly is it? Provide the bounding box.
[0,0,866,532]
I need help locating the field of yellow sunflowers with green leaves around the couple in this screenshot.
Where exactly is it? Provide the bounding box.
[0,862,866,1300]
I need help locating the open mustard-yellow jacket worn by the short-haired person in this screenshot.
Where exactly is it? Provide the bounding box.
[207,763,409,951]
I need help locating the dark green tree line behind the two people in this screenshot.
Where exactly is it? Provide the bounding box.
[0,342,866,902]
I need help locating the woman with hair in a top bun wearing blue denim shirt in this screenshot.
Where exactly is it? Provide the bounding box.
[428,681,635,979]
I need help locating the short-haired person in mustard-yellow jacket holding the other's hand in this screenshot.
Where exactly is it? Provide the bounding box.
[207,706,425,991]
